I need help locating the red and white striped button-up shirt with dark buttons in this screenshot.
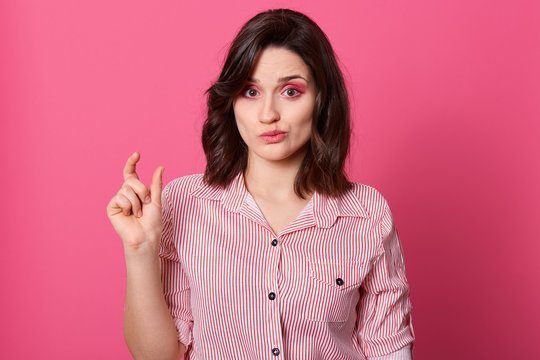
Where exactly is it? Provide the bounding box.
[160,173,414,360]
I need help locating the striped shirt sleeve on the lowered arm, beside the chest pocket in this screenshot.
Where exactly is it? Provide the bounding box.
[357,201,415,360]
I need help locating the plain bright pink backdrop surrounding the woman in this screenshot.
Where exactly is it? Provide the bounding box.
[0,0,540,359]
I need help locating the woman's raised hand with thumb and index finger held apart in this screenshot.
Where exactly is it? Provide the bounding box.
[107,152,165,255]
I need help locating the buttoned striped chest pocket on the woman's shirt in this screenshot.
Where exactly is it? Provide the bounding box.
[305,260,369,322]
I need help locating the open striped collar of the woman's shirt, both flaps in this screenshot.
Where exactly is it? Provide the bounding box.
[191,172,369,228]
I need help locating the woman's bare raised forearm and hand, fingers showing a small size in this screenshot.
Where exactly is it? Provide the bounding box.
[107,152,186,360]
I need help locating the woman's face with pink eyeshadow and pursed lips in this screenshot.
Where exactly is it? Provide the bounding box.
[233,47,317,166]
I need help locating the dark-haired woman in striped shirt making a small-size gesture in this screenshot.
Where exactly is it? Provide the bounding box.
[107,9,414,359]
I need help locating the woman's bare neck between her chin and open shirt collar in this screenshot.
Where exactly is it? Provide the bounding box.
[244,151,305,201]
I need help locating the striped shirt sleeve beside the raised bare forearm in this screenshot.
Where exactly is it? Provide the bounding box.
[159,183,193,348]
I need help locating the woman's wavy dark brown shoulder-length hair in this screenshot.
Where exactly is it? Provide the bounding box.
[202,9,352,198]
